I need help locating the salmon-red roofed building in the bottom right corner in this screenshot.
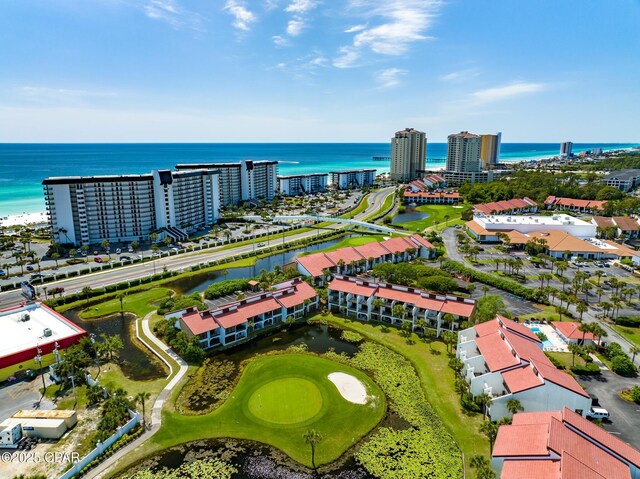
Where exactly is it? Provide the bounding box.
[491,407,640,479]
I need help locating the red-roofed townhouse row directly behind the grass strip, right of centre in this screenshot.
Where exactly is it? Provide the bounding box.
[327,275,475,336]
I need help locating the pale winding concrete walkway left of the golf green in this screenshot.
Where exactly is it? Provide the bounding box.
[83,312,188,479]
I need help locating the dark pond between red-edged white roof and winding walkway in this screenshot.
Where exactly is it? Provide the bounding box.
[64,309,168,381]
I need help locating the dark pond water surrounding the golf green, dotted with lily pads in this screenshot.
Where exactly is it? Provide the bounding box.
[121,324,410,479]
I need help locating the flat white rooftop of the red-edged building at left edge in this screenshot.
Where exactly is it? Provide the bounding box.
[0,303,86,358]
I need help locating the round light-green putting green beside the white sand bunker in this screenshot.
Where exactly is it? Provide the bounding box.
[248,378,322,424]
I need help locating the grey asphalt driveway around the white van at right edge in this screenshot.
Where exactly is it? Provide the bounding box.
[579,370,640,448]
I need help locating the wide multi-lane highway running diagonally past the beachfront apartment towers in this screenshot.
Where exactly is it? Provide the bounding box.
[0,187,394,309]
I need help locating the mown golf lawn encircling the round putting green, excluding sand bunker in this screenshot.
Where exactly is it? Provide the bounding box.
[151,354,386,466]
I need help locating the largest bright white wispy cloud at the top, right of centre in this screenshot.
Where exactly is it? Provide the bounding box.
[336,0,442,64]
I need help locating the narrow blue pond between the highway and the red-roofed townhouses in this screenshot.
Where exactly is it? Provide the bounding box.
[166,236,348,294]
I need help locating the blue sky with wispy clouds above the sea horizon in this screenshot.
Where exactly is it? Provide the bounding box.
[0,0,640,143]
